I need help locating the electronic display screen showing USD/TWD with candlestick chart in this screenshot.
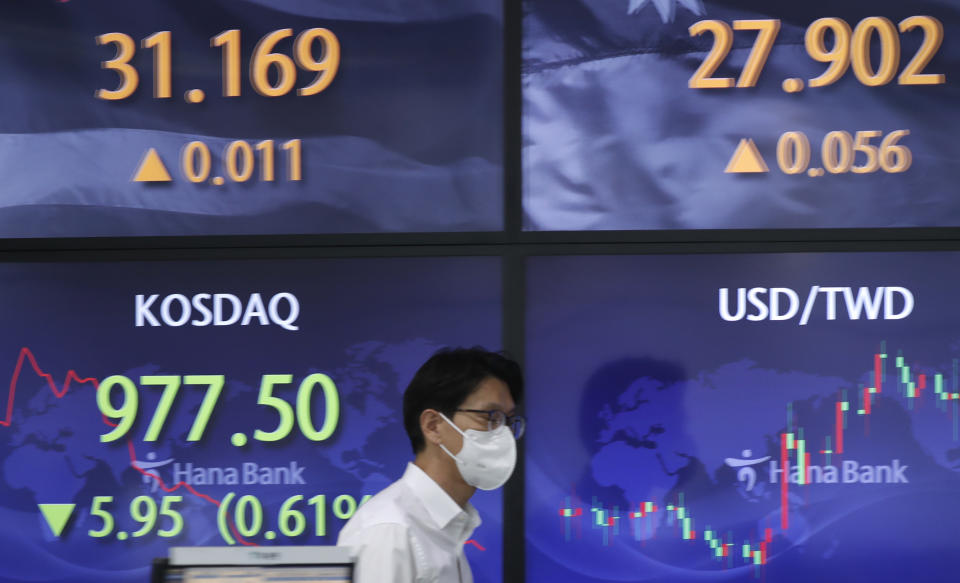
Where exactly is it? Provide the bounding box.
[524,252,960,583]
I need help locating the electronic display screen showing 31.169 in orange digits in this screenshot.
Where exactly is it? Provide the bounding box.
[0,0,503,237]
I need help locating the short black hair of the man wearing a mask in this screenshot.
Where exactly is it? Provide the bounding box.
[403,346,523,454]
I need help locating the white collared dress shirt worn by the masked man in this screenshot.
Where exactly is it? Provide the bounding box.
[337,463,480,583]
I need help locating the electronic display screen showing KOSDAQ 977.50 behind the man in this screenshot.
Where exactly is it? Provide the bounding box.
[0,257,503,583]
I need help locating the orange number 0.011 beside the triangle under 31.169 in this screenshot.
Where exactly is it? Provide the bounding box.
[180,140,303,183]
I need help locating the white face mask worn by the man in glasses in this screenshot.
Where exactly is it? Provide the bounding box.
[440,413,517,490]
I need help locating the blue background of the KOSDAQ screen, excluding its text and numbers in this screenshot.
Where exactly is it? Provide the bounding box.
[0,257,503,583]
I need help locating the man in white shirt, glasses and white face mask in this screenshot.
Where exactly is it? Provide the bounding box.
[337,348,525,583]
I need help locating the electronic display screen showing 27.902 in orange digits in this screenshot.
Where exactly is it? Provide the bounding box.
[523,0,960,231]
